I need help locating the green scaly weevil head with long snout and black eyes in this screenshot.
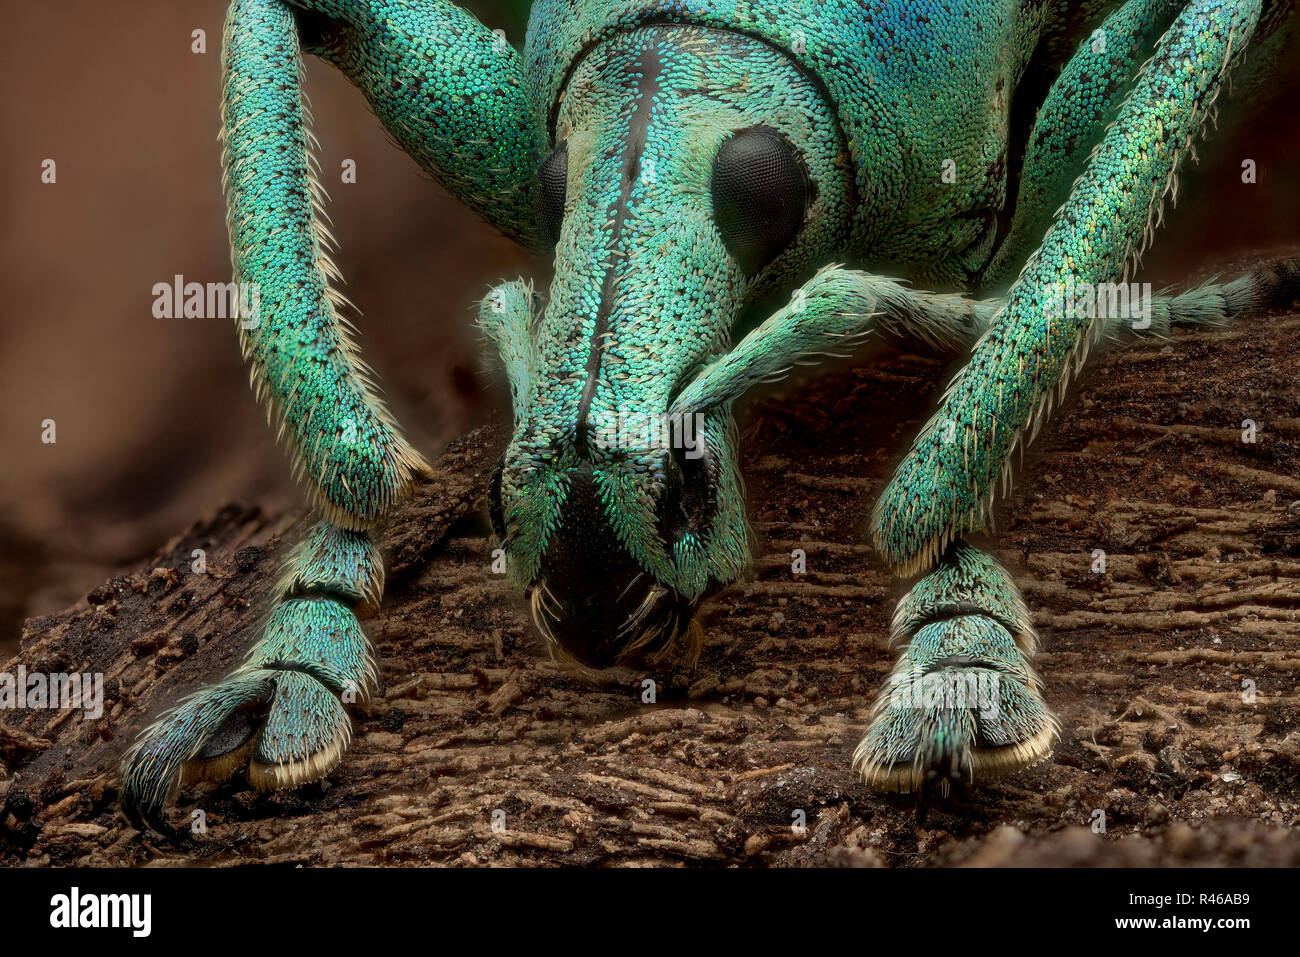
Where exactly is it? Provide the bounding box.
[489,26,852,667]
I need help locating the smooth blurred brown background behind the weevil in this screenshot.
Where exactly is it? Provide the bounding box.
[0,0,1300,657]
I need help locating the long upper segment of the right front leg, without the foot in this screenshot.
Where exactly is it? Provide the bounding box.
[874,0,1260,573]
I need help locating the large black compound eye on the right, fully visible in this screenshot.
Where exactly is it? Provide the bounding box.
[712,126,811,273]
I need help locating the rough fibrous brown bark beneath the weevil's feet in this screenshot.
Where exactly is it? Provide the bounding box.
[0,308,1300,866]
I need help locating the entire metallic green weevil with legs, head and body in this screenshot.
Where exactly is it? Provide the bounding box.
[122,0,1297,826]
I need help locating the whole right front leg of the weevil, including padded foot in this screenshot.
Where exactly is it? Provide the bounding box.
[858,0,1277,788]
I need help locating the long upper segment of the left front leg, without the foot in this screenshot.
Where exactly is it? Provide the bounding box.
[222,0,426,528]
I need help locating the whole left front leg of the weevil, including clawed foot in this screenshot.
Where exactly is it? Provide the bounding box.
[122,0,387,830]
